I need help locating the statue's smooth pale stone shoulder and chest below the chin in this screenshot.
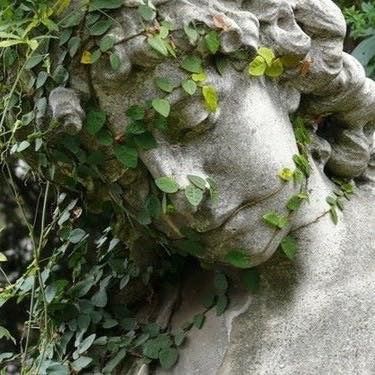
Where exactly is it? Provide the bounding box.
[157,185,375,375]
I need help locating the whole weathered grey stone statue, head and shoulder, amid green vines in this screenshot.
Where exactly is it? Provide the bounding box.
[50,0,375,375]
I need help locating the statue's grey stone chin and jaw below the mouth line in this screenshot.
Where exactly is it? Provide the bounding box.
[158,185,295,267]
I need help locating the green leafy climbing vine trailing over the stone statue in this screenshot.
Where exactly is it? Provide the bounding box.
[0,0,356,375]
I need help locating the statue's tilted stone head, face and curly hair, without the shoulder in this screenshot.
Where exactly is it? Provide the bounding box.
[56,0,375,265]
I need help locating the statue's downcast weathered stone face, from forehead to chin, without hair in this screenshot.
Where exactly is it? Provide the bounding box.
[93,57,304,263]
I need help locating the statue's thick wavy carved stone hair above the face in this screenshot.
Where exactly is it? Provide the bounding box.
[70,0,375,178]
